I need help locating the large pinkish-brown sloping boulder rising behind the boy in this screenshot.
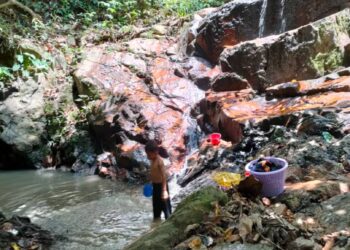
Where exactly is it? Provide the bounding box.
[74,39,206,170]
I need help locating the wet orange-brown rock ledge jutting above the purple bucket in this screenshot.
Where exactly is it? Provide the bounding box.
[205,77,350,143]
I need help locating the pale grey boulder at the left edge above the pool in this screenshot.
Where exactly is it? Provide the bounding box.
[0,77,47,168]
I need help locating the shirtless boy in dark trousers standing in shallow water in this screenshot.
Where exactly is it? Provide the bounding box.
[145,141,171,220]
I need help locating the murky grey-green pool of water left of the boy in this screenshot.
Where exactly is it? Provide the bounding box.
[0,171,152,250]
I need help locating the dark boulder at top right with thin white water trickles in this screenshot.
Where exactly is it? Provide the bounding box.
[195,0,348,62]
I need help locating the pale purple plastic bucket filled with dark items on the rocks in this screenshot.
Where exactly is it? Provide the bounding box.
[245,157,288,197]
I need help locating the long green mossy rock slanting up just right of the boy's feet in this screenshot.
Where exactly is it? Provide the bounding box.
[125,187,228,250]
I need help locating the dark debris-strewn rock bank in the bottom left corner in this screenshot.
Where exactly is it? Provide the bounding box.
[0,212,54,249]
